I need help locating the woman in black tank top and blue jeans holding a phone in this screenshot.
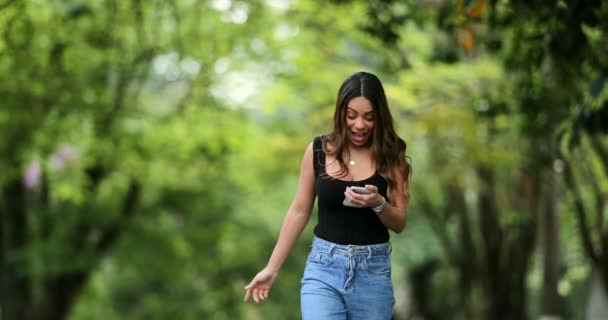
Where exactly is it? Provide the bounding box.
[245,72,411,320]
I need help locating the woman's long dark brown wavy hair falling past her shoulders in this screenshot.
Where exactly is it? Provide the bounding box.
[323,72,412,193]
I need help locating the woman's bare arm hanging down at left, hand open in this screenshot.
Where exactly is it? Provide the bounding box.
[245,143,315,303]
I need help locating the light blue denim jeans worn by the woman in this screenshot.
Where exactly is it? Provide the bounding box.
[300,237,395,320]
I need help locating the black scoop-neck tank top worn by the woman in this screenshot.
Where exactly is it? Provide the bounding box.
[313,137,389,245]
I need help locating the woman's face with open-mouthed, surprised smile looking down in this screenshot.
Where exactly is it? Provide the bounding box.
[346,97,376,147]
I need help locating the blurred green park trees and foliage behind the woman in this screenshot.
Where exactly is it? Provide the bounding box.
[0,0,608,320]
